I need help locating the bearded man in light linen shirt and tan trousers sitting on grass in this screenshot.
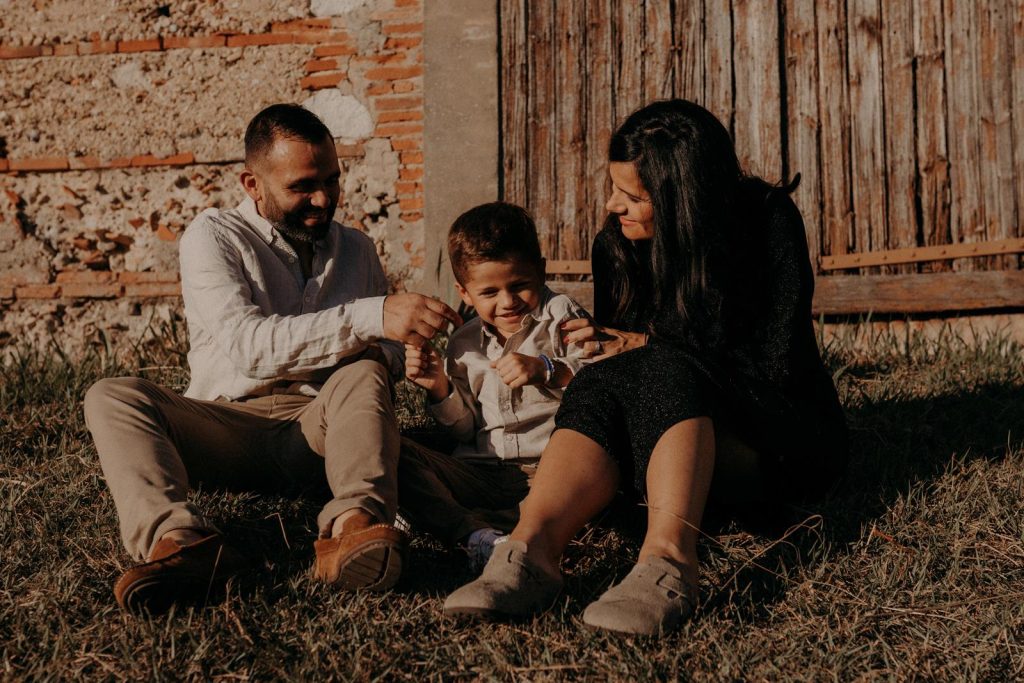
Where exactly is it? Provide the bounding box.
[85,104,460,611]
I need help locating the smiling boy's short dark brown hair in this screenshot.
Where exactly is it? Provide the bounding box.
[449,202,544,286]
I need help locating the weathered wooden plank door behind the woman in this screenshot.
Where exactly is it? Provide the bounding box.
[499,0,1024,310]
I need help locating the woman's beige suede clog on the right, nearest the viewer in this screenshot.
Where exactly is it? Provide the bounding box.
[583,557,697,636]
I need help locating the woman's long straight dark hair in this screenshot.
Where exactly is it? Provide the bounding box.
[606,99,792,344]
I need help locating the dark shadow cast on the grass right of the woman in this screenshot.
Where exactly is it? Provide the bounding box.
[675,382,1024,621]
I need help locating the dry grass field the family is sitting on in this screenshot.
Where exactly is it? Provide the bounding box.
[0,321,1024,681]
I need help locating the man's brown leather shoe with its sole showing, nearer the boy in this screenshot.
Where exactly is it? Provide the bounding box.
[313,511,409,591]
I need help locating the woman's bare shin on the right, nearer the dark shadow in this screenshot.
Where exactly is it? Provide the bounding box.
[639,418,715,587]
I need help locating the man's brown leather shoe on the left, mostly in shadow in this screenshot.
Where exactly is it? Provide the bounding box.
[114,533,248,614]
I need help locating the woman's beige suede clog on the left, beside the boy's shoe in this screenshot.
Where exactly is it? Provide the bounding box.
[444,540,562,620]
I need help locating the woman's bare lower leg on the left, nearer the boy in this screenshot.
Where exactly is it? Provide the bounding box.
[509,429,618,572]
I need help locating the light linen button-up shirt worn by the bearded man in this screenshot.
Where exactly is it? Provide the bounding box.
[179,199,403,400]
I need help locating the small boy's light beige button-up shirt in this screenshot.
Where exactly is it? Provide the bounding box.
[429,288,590,462]
